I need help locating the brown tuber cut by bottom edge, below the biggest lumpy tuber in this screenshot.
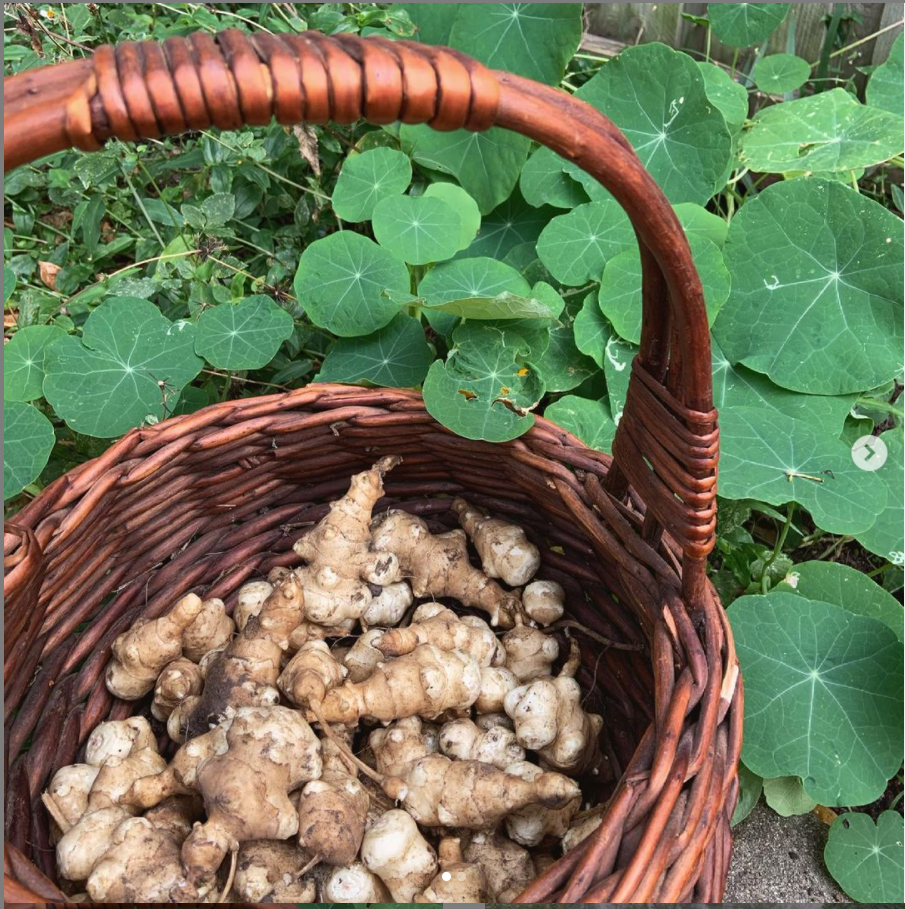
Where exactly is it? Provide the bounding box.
[234,840,317,903]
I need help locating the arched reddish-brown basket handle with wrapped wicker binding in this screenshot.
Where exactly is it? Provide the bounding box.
[4,35,718,602]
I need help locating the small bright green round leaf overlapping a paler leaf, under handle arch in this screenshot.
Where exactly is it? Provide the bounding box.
[371,196,462,265]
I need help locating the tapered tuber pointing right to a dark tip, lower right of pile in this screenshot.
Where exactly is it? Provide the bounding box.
[394,754,581,830]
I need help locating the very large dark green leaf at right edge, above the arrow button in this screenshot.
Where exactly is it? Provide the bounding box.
[713,180,903,394]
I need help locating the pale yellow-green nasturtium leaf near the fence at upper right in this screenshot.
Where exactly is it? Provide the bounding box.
[739,88,903,174]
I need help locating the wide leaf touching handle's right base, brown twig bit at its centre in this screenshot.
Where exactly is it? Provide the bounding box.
[720,407,886,532]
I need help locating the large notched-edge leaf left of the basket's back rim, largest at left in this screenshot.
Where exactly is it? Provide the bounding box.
[44,297,204,439]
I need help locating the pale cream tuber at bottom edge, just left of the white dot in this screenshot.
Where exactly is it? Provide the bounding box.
[361,809,437,903]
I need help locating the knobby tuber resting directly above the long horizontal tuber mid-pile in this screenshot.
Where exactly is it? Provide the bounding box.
[374,603,506,666]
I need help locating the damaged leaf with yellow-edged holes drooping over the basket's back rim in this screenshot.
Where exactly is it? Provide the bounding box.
[422,322,544,442]
